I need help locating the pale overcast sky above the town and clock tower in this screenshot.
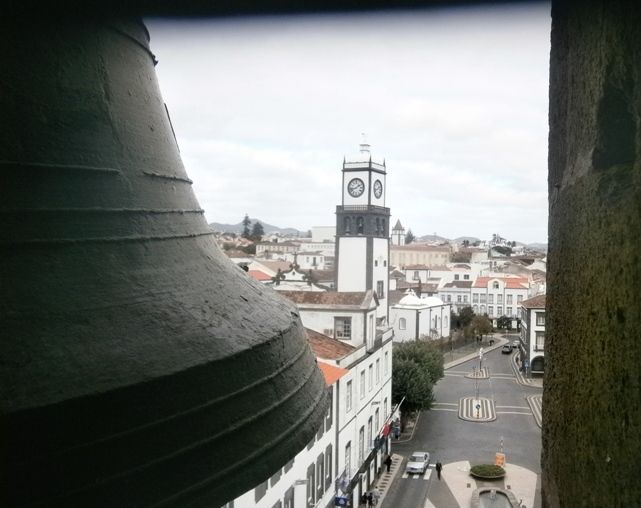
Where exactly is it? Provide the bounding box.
[147,4,550,242]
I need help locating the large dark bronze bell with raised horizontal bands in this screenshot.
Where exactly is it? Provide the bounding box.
[0,17,326,507]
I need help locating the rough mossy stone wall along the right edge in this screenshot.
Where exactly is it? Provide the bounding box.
[542,1,641,508]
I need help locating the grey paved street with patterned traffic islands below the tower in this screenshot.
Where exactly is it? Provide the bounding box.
[382,337,541,508]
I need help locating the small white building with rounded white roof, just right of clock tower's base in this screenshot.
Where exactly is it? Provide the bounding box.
[390,292,452,342]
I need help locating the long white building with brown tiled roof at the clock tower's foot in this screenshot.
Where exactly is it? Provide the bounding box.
[281,290,393,506]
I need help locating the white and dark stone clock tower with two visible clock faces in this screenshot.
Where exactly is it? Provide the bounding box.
[336,142,390,321]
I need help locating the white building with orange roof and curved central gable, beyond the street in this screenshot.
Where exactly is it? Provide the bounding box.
[472,274,529,328]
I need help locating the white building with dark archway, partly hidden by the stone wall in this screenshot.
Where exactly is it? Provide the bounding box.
[521,295,545,376]
